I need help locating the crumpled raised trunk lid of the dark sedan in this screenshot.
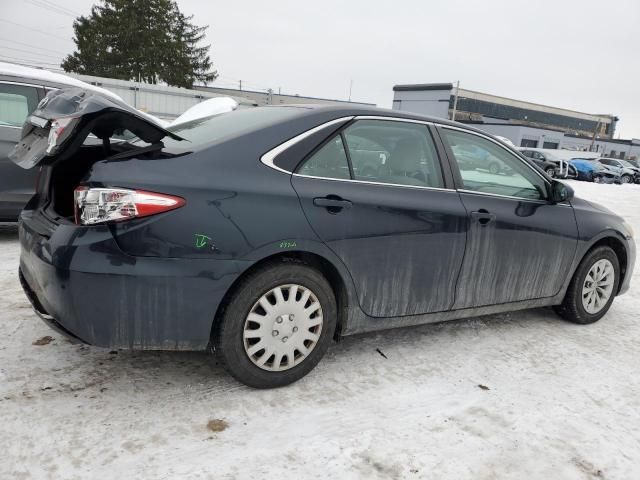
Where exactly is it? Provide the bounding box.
[9,87,182,169]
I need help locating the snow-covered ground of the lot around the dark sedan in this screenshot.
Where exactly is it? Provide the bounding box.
[0,182,640,479]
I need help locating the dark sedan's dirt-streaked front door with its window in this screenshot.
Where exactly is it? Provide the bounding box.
[439,127,578,308]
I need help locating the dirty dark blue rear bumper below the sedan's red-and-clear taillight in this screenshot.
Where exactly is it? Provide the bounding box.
[20,219,244,350]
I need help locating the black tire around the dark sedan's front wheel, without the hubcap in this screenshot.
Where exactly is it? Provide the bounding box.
[554,246,620,325]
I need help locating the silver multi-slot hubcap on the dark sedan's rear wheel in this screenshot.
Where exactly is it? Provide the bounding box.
[243,284,323,372]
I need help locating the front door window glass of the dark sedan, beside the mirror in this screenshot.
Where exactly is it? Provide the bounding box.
[442,128,546,200]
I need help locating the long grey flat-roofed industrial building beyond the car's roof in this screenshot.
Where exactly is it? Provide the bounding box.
[393,83,640,158]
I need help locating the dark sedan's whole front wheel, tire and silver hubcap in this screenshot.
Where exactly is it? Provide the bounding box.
[555,247,620,325]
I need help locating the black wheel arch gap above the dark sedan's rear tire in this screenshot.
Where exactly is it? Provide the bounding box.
[210,250,349,340]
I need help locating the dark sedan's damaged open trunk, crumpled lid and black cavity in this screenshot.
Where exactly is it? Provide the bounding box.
[9,88,181,221]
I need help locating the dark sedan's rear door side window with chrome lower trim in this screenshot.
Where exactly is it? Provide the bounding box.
[298,120,444,188]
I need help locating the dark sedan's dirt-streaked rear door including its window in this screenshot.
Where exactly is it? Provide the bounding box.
[292,118,467,317]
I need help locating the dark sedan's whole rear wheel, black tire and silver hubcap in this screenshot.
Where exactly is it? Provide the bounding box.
[214,263,337,388]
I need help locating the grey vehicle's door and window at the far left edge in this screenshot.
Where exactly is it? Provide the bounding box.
[0,81,42,220]
